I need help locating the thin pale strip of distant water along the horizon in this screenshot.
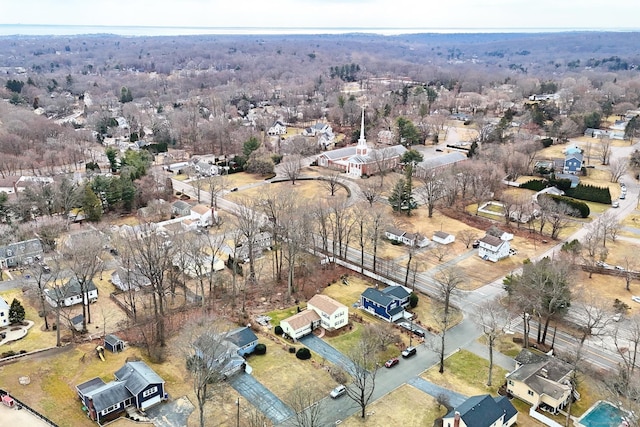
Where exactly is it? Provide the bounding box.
[0,24,640,36]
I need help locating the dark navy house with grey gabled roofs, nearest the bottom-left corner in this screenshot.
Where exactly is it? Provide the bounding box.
[76,361,168,424]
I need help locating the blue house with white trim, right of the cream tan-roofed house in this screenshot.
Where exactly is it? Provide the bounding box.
[360,286,411,322]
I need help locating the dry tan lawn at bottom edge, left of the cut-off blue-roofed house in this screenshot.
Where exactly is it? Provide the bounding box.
[341,385,446,427]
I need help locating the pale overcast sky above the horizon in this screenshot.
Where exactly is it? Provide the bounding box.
[0,0,640,32]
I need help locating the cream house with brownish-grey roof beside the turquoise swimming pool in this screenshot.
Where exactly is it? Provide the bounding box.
[507,349,573,414]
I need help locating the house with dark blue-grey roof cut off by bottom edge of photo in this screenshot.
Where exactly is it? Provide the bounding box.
[442,394,518,427]
